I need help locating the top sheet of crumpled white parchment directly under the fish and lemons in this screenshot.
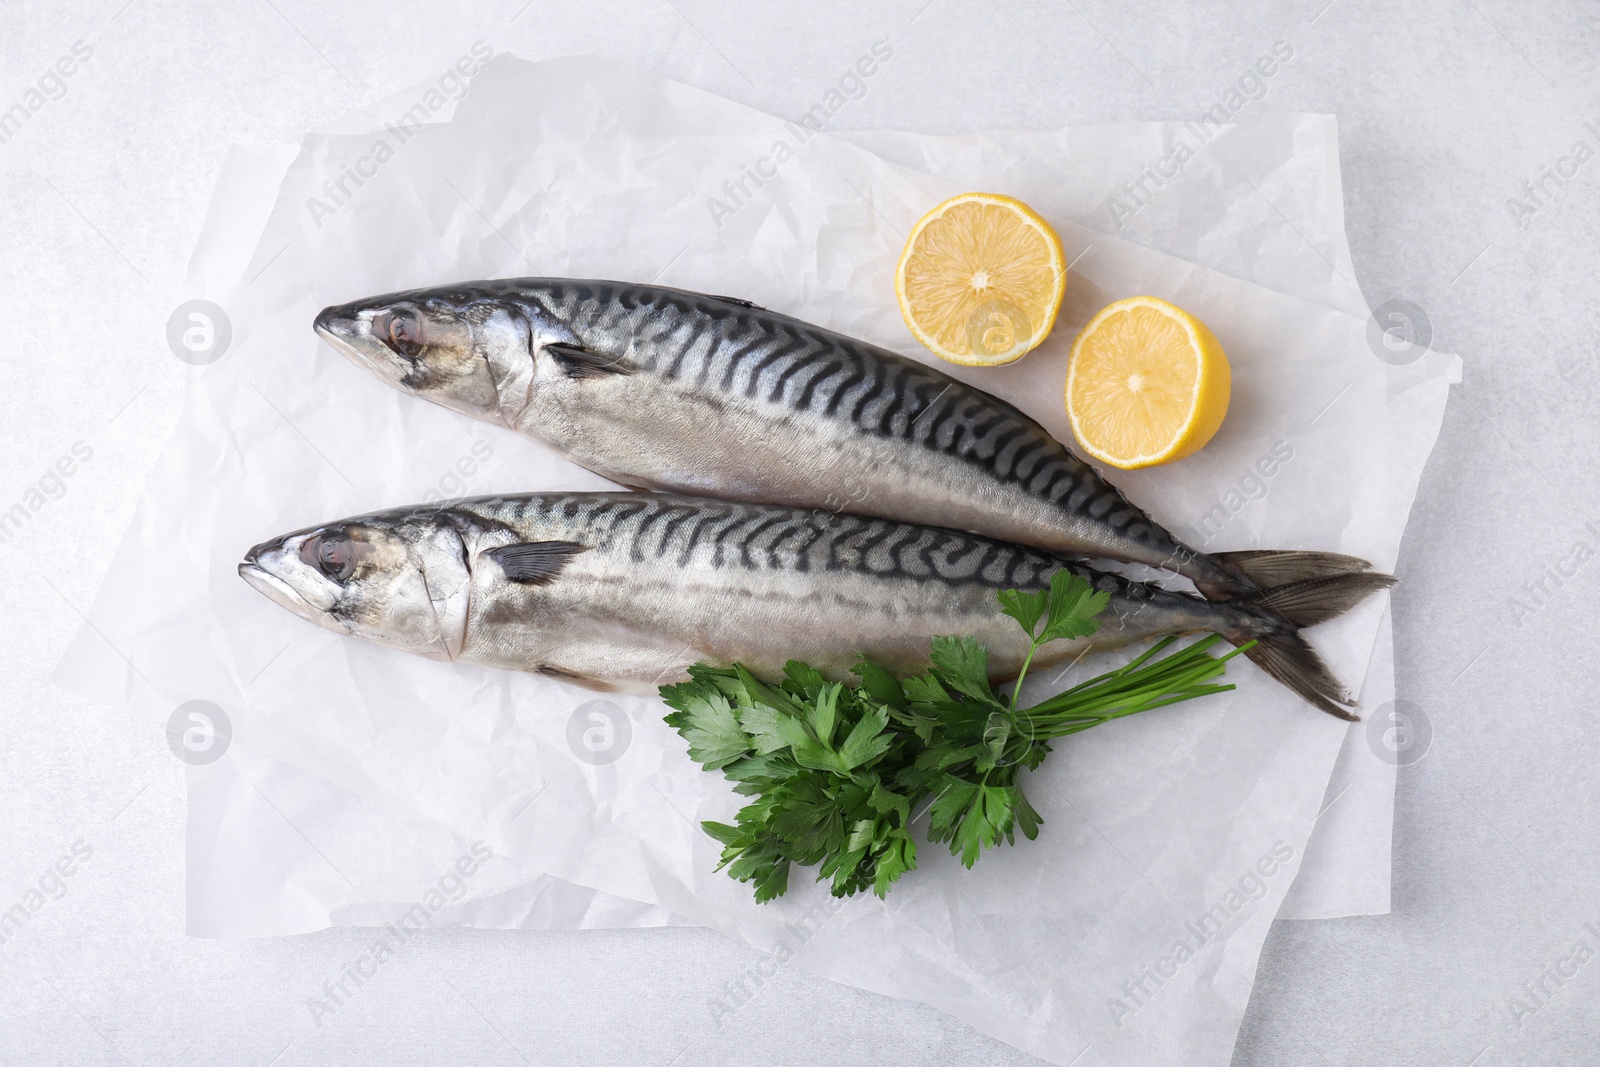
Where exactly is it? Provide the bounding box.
[59,59,1458,1062]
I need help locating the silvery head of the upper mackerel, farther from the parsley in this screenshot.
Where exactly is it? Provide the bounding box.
[314,290,530,424]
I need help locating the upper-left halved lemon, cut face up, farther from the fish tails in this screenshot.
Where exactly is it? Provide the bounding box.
[894,192,1067,366]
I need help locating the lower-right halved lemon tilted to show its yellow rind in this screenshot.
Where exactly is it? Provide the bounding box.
[1067,296,1232,470]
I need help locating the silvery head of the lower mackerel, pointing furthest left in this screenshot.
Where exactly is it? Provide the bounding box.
[238,515,472,659]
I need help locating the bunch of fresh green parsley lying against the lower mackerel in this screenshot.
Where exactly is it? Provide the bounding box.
[661,569,1248,902]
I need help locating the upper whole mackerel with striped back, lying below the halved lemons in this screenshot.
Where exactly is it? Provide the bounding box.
[315,278,1368,598]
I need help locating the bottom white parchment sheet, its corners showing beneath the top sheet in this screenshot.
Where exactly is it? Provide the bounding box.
[189,97,1394,936]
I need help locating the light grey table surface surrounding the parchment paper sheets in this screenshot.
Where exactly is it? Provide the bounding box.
[0,0,1600,1067]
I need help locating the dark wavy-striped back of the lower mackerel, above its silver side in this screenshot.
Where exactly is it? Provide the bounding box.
[451,493,1174,600]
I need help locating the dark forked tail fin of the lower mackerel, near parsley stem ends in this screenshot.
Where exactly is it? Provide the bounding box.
[1227,571,1395,721]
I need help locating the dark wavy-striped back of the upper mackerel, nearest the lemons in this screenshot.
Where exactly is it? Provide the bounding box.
[499,278,1192,560]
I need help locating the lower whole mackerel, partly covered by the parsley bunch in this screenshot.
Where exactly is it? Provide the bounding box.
[238,493,1392,718]
